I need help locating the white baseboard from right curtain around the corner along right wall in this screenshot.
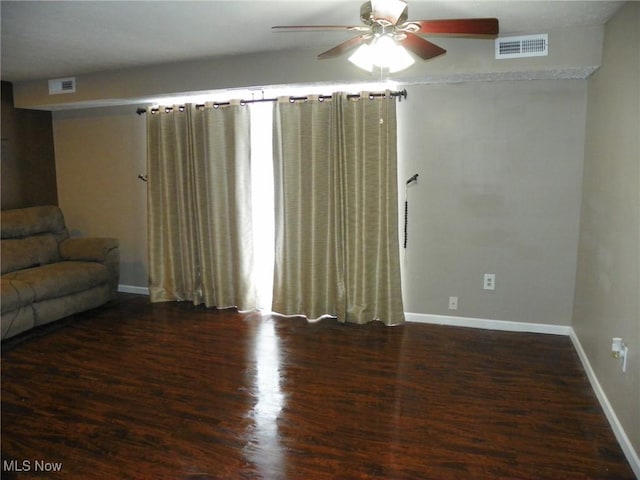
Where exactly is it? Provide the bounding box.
[404,313,640,479]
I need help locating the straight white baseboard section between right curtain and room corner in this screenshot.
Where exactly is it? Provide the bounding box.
[404,313,572,335]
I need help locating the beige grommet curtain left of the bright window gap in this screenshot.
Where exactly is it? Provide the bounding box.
[147,102,255,310]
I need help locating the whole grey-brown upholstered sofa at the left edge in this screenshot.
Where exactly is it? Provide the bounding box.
[0,206,120,340]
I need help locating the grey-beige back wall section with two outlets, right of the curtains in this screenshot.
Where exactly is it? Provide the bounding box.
[398,80,586,325]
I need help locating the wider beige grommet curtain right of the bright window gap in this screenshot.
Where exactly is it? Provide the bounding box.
[273,94,404,324]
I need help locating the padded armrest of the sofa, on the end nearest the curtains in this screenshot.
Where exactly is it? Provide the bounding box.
[60,237,120,298]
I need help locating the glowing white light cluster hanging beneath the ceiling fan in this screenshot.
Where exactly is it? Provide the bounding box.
[349,35,415,73]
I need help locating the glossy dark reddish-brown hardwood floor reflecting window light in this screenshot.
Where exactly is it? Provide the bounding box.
[2,295,635,480]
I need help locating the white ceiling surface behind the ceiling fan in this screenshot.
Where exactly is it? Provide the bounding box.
[0,0,624,82]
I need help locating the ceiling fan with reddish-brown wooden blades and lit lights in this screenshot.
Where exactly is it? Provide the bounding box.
[272,0,499,71]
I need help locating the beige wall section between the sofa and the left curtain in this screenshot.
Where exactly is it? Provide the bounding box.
[53,107,148,287]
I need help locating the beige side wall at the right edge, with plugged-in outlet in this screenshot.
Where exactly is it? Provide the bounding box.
[573,2,640,458]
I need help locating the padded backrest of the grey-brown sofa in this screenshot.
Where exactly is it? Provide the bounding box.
[0,205,69,274]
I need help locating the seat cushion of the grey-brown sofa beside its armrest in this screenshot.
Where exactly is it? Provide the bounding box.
[3,262,109,302]
